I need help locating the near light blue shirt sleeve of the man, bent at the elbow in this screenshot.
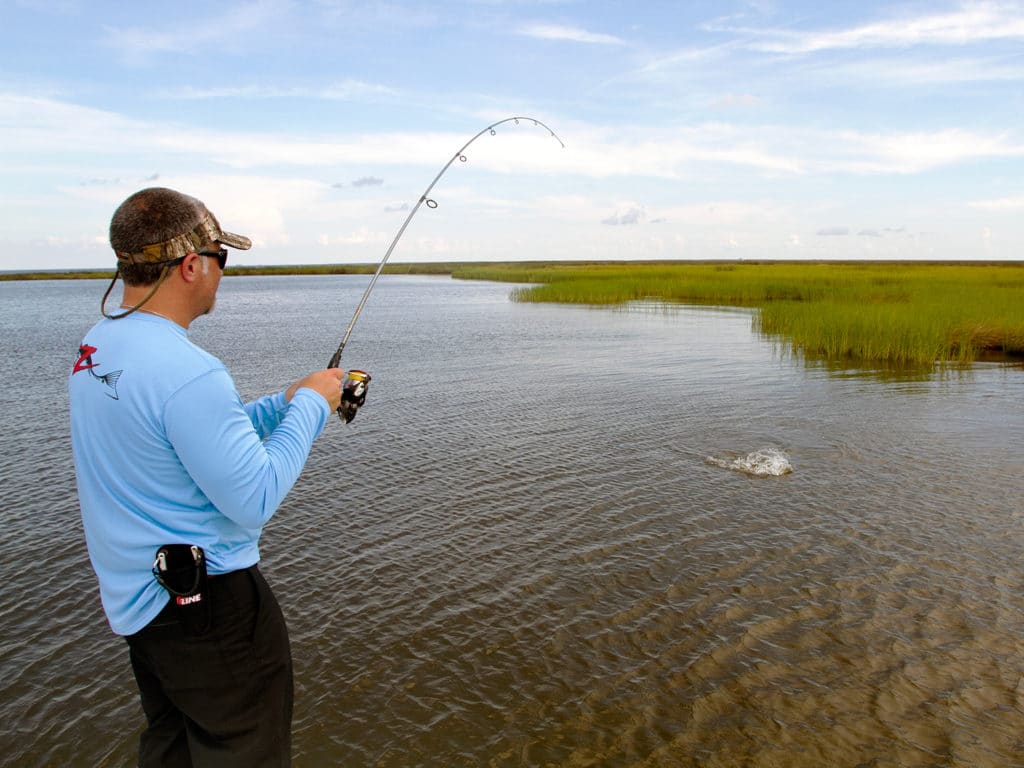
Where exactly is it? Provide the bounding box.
[164,369,330,529]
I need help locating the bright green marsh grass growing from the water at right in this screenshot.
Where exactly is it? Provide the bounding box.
[455,262,1024,366]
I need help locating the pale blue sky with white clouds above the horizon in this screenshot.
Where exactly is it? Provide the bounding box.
[0,0,1024,270]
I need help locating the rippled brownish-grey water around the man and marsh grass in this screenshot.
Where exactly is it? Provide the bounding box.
[0,276,1024,768]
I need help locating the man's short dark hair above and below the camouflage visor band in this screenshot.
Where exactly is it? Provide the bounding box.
[111,186,206,286]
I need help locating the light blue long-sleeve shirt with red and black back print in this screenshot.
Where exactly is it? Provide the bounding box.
[69,312,330,635]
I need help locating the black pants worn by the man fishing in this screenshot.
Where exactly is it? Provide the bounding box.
[125,565,293,768]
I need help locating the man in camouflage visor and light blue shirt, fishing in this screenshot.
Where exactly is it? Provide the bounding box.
[69,188,344,768]
